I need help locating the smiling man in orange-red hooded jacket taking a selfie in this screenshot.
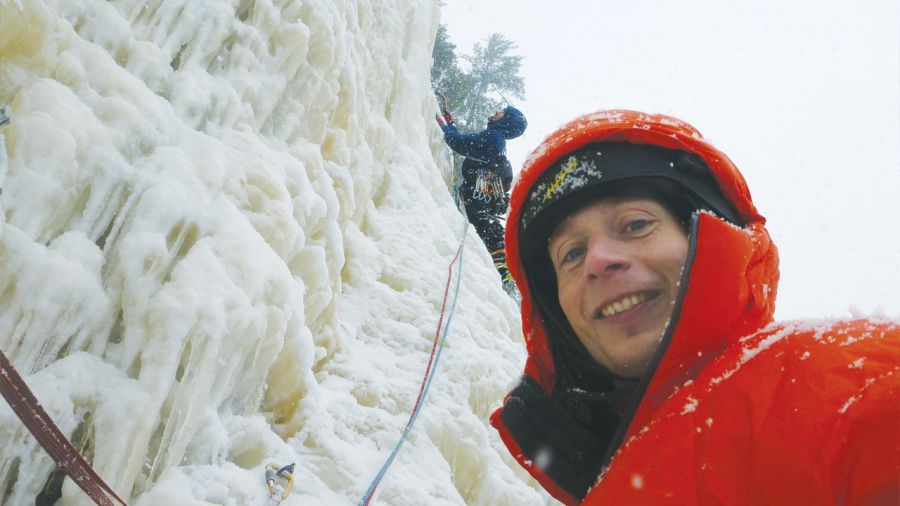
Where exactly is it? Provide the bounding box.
[491,110,900,506]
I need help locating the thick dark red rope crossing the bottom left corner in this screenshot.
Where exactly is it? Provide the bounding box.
[0,350,128,506]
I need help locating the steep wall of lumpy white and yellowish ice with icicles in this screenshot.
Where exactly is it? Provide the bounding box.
[0,0,547,505]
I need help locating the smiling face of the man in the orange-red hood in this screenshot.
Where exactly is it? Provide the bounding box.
[547,198,688,378]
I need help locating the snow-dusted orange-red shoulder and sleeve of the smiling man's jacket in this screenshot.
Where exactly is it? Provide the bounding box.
[584,320,900,505]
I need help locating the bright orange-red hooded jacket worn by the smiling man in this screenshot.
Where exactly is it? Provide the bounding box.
[491,110,900,505]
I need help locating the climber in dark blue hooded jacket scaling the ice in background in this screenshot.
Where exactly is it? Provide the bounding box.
[437,105,528,284]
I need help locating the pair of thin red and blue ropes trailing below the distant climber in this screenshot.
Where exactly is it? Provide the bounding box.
[357,187,469,506]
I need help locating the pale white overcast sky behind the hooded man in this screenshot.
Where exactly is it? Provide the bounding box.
[442,0,900,319]
